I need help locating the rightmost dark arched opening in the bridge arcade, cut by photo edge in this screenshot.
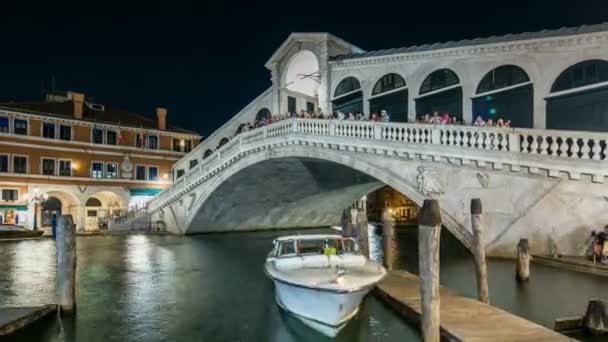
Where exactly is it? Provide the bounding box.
[547,59,608,132]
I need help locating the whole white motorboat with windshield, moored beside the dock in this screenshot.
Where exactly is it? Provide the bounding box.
[265,235,386,337]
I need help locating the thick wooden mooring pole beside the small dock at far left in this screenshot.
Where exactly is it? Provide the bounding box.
[55,215,76,314]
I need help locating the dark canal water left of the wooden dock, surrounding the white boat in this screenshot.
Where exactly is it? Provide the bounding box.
[0,232,420,342]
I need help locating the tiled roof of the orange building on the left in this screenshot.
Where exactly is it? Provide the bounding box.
[0,101,200,135]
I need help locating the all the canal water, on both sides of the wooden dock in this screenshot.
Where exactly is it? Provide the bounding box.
[0,228,608,342]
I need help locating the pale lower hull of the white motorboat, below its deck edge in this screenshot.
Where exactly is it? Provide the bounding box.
[274,279,370,336]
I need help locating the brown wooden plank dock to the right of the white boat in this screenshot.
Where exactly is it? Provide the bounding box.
[375,271,575,342]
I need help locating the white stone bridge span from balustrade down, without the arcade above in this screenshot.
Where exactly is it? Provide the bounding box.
[147,119,608,255]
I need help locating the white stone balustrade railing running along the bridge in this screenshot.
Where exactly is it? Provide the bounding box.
[149,119,608,212]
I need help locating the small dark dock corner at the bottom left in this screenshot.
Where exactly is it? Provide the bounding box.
[0,304,57,336]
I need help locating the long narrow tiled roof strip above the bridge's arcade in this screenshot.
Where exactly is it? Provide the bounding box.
[332,23,608,61]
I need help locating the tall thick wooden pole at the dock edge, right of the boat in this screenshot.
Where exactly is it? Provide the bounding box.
[418,200,441,342]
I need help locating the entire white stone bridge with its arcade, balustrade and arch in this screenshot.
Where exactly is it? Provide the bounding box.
[140,25,608,254]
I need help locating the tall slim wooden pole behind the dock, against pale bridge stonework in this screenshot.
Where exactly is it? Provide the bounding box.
[471,198,490,304]
